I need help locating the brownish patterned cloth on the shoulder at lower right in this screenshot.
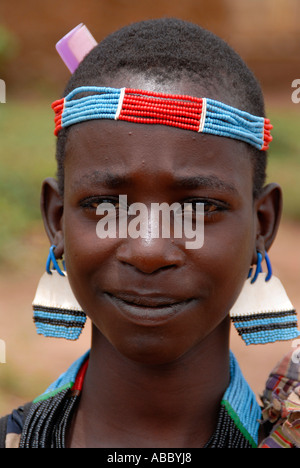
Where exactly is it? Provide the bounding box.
[259,347,300,448]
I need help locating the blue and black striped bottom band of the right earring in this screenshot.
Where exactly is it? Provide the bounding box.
[231,310,300,345]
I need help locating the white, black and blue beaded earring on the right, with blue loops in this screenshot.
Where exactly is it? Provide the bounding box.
[230,252,300,345]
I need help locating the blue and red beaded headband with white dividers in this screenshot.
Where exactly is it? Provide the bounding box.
[52,86,272,151]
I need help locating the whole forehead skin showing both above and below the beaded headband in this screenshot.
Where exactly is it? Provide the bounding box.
[65,70,253,193]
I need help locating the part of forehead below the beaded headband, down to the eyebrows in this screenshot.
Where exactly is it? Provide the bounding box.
[65,120,253,197]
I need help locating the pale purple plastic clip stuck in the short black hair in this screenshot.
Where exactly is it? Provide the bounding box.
[56,23,97,73]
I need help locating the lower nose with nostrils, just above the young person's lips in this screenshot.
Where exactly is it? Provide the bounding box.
[117,238,185,274]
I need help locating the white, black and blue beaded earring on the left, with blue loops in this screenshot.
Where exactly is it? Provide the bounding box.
[32,245,86,340]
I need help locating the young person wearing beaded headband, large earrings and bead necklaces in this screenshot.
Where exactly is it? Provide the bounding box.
[2,19,300,448]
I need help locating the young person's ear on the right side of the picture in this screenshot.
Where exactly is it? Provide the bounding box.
[255,184,282,257]
